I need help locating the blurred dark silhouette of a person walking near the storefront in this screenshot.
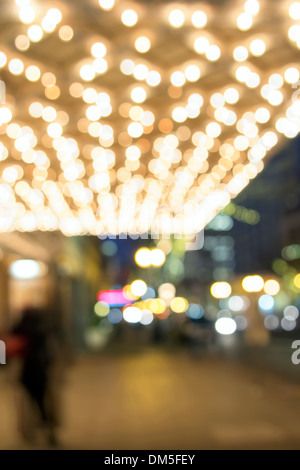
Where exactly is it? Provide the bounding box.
[13,308,56,445]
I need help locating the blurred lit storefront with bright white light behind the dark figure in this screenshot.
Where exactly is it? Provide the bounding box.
[0,233,103,347]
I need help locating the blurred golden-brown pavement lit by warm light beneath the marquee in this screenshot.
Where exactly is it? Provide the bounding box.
[0,350,300,450]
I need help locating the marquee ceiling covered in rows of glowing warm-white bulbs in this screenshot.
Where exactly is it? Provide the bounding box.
[0,0,300,236]
